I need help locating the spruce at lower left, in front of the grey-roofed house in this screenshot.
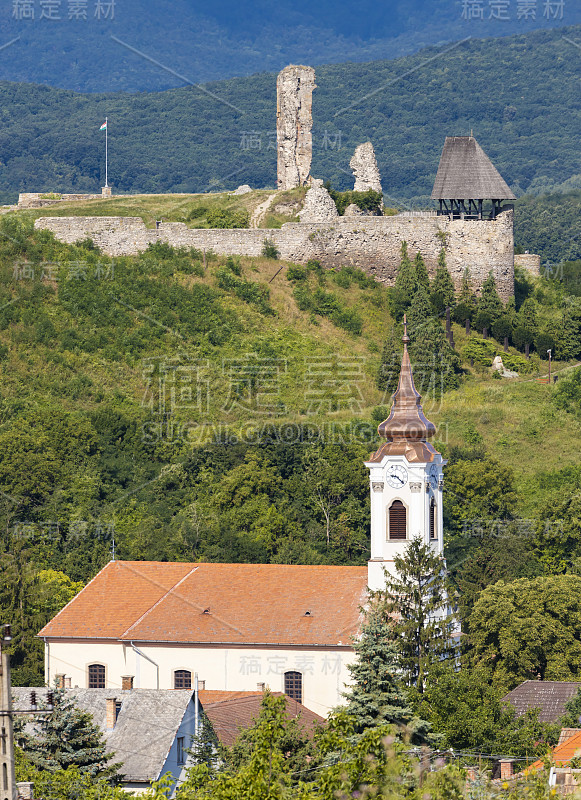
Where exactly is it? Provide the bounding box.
[20,689,121,778]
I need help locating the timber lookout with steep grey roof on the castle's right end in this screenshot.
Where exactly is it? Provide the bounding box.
[432,136,516,219]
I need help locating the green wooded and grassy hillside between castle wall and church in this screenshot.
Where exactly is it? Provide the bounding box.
[0,209,581,683]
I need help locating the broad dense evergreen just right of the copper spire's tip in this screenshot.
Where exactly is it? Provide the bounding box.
[410,317,462,402]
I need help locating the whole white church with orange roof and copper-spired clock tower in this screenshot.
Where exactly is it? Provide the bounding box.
[39,322,446,716]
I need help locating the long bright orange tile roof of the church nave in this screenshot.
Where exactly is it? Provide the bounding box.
[39,561,367,646]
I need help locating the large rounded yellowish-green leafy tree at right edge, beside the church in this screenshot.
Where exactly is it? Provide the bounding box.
[469,575,581,691]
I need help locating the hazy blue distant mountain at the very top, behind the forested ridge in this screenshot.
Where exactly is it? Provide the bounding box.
[0,0,581,92]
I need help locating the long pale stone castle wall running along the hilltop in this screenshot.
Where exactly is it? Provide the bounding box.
[35,209,514,301]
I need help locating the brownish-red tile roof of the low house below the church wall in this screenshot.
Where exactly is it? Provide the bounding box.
[200,692,325,747]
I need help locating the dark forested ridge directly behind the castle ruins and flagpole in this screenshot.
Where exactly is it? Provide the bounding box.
[0,27,581,220]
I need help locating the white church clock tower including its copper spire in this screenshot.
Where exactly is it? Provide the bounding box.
[365,317,447,590]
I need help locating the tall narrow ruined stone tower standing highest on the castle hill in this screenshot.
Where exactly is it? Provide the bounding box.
[276,64,316,189]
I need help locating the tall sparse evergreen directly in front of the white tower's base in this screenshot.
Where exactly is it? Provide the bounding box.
[385,537,454,695]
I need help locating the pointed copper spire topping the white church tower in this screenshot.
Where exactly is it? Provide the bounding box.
[377,314,436,442]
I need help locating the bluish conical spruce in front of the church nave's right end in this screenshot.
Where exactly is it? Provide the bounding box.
[343,605,413,733]
